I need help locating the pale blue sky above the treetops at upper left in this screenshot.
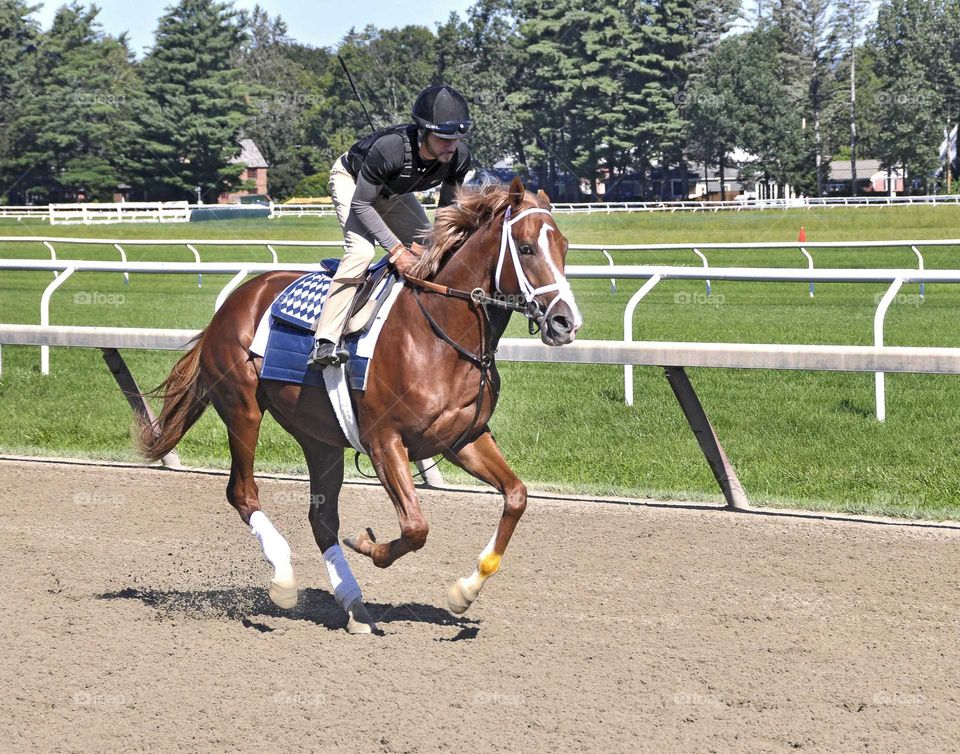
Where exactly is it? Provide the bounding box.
[36,0,473,56]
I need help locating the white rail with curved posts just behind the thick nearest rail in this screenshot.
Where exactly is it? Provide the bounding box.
[0,259,960,421]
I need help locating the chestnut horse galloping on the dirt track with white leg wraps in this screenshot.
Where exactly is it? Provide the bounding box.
[140,178,583,633]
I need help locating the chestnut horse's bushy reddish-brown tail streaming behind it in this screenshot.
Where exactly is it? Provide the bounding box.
[136,330,210,461]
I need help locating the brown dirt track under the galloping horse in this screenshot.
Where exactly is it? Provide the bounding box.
[0,462,960,752]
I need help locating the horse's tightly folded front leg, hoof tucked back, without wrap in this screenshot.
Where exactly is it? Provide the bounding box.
[343,435,430,568]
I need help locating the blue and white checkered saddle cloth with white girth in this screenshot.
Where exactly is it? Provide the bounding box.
[249,271,403,452]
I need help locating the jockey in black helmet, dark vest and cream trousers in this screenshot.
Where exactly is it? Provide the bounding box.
[307,86,472,367]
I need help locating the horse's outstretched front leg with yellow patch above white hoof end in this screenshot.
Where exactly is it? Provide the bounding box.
[444,431,527,615]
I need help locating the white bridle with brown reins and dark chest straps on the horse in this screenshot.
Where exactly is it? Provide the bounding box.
[404,200,571,458]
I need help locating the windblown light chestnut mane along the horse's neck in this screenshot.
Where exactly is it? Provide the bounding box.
[410,183,528,279]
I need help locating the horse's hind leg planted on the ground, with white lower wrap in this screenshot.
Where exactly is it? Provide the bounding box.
[299,438,377,634]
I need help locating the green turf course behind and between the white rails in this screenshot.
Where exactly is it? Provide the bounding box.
[0,207,960,518]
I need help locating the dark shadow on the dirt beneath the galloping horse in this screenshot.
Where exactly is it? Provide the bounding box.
[97,586,480,639]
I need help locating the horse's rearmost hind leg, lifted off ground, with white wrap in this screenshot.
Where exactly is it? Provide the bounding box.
[213,375,297,610]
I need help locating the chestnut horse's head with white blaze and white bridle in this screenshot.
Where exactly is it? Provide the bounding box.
[494,176,583,346]
